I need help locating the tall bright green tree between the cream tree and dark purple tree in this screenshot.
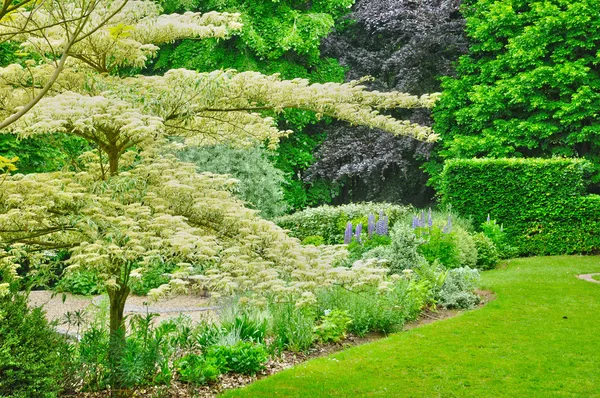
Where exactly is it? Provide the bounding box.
[151,0,354,209]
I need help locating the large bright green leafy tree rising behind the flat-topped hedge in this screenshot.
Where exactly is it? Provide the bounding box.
[432,0,600,182]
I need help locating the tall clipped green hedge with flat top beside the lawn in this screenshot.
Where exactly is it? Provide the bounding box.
[440,159,600,255]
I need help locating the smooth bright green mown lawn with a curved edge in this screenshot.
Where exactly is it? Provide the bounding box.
[224,256,600,397]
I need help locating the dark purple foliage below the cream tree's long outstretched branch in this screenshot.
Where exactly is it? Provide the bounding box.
[305,124,432,206]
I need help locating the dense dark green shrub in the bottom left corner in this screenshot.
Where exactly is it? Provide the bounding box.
[0,290,64,397]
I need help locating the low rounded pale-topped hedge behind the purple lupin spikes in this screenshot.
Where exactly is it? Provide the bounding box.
[274,203,412,244]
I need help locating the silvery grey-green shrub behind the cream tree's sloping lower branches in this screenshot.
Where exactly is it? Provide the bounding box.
[177,145,286,219]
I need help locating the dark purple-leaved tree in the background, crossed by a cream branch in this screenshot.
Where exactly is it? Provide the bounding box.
[308,0,467,206]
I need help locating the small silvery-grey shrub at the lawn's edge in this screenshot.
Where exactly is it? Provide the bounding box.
[438,267,479,308]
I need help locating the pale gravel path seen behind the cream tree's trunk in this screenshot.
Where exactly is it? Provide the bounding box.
[29,290,217,332]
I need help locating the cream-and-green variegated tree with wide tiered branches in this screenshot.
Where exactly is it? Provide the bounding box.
[0,0,436,346]
